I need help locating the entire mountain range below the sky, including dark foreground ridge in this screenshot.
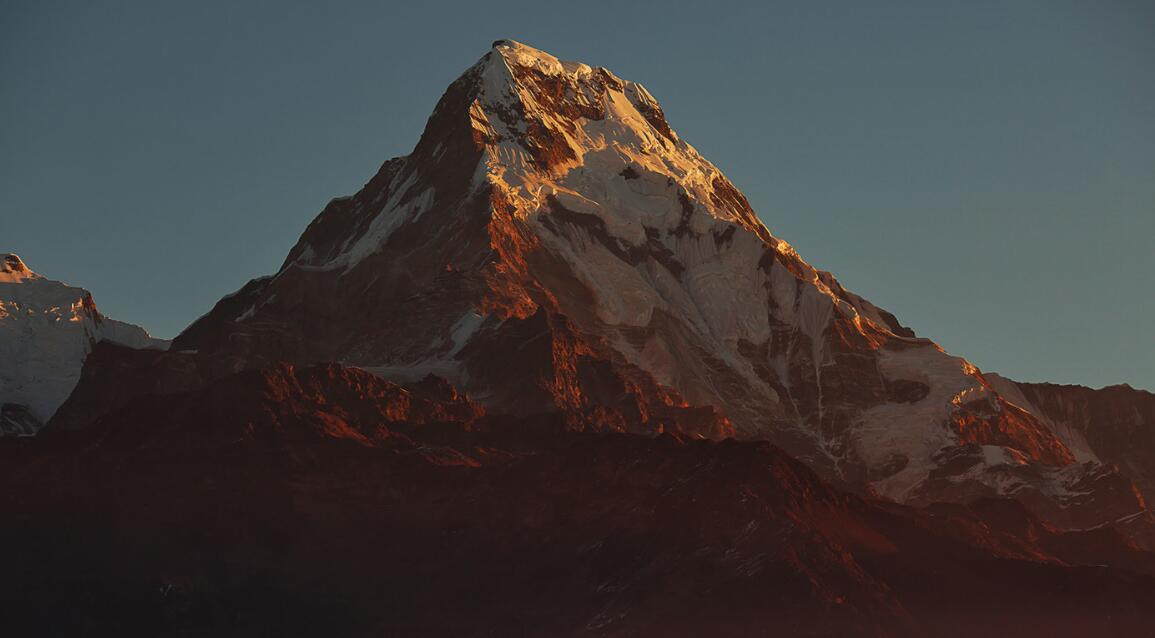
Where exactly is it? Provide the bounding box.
[9,40,1155,637]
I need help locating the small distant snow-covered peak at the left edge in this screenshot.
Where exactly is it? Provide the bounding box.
[0,253,167,435]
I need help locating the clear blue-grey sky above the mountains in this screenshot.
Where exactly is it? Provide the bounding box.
[0,0,1155,390]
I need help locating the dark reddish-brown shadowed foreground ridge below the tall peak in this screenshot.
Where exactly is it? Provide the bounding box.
[0,360,1155,636]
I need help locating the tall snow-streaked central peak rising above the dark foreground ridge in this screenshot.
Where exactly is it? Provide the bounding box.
[176,40,1146,527]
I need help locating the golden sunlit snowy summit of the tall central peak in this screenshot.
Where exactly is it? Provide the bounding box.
[465,40,769,236]
